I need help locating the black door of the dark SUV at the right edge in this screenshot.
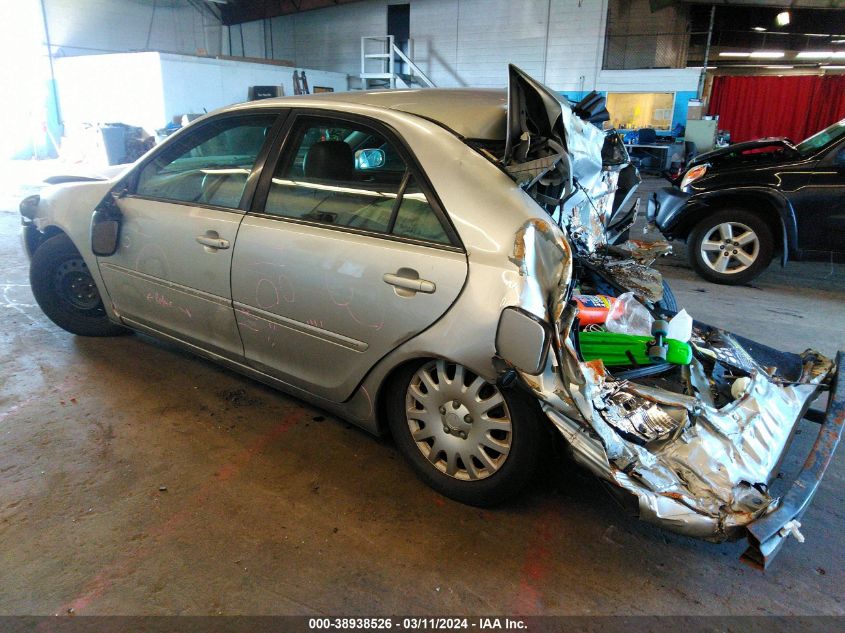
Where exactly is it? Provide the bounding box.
[796,141,845,256]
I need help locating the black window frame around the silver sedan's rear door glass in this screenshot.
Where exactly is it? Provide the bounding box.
[247,108,466,253]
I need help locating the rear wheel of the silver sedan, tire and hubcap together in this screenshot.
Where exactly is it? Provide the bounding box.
[387,360,543,507]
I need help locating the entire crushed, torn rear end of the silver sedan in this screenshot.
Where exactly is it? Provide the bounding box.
[495,67,845,567]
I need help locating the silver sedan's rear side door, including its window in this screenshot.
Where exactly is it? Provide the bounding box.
[232,113,467,401]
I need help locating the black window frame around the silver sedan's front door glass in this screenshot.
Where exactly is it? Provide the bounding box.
[124,108,290,215]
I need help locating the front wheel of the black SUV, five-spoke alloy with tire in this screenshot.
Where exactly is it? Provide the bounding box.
[687,209,774,285]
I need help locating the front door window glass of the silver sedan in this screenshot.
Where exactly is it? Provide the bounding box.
[135,115,276,209]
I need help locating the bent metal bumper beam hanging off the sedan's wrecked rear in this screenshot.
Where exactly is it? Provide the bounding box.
[742,352,845,569]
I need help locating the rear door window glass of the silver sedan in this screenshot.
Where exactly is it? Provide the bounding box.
[264,117,451,244]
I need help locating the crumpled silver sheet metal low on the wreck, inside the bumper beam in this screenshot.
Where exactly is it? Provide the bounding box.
[537,326,832,542]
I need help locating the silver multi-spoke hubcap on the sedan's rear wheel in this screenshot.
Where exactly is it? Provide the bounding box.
[405,360,513,481]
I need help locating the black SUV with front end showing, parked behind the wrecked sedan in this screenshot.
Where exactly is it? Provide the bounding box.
[647,119,845,284]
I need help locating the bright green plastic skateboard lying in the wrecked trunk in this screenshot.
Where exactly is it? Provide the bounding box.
[578,332,692,367]
